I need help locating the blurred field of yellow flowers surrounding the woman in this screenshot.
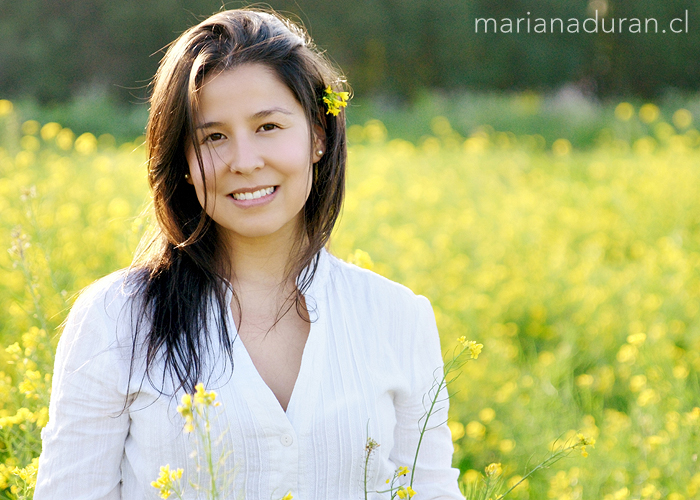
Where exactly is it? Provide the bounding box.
[0,96,700,500]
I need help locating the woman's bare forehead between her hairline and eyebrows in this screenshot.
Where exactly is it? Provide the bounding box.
[197,63,304,120]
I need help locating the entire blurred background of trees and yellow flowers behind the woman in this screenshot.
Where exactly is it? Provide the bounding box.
[0,0,700,500]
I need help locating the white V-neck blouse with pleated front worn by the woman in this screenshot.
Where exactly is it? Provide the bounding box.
[34,250,463,500]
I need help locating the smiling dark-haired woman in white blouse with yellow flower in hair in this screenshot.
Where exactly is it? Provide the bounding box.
[35,10,461,500]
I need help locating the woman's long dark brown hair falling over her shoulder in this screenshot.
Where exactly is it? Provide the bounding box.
[128,10,347,394]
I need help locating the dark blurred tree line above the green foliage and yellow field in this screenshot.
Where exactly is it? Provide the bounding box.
[0,0,700,104]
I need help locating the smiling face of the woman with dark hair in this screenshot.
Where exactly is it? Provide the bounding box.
[187,63,324,247]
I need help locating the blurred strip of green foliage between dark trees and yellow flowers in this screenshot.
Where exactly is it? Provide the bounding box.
[8,87,700,149]
